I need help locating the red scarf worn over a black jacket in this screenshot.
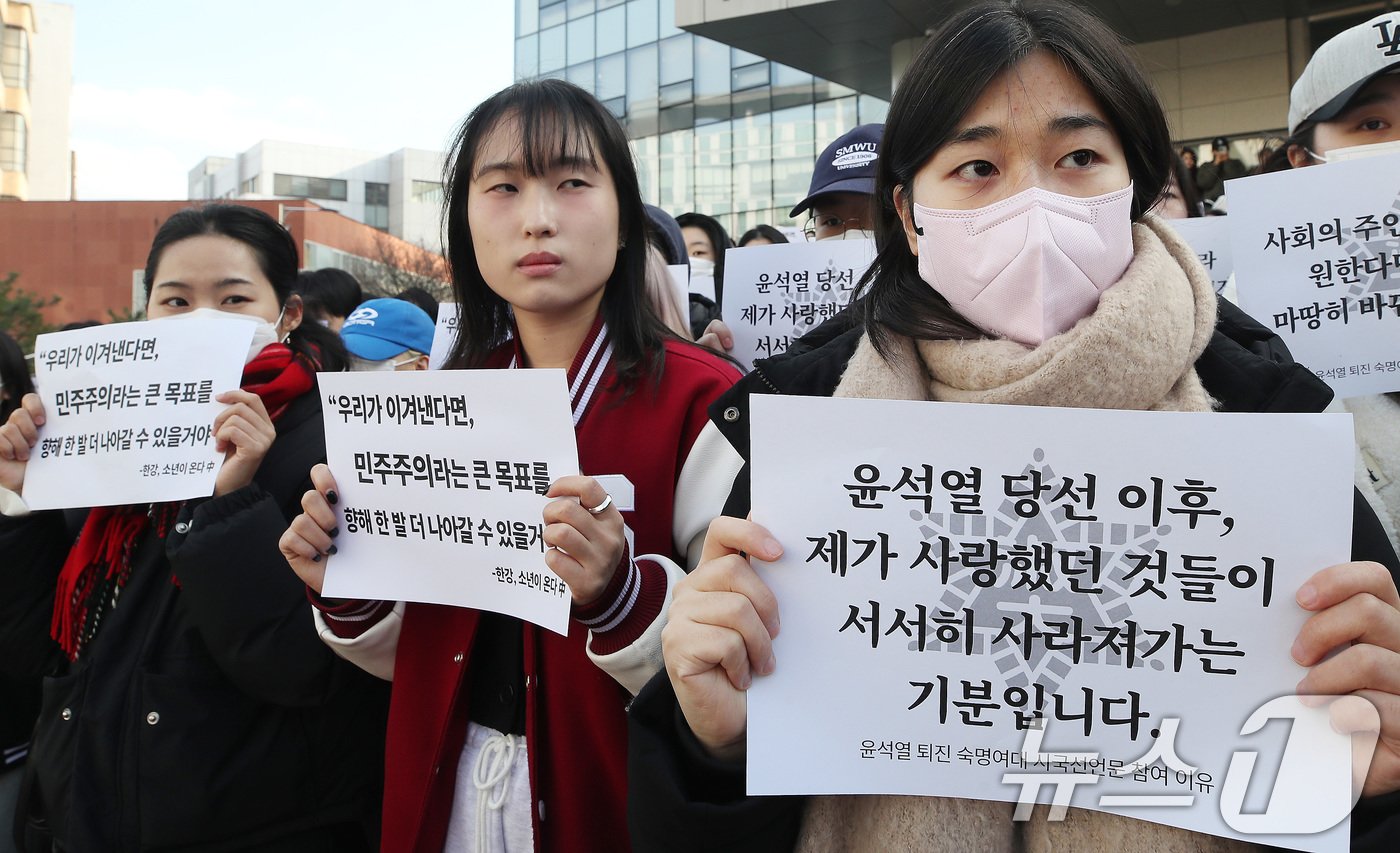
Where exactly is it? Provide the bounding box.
[49,343,316,661]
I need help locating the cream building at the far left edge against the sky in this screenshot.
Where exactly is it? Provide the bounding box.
[0,0,73,202]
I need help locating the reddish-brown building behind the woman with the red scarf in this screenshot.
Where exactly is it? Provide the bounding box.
[0,199,447,325]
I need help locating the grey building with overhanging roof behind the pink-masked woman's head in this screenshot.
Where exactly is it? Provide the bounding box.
[672,0,1397,172]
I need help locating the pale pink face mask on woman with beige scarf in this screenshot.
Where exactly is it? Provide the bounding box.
[913,183,1133,347]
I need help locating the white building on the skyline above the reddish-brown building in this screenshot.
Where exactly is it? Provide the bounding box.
[189,140,442,252]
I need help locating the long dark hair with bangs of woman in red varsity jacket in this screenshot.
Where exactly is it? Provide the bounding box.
[442,80,673,392]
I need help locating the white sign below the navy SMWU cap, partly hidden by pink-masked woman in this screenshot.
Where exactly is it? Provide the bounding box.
[724,240,875,368]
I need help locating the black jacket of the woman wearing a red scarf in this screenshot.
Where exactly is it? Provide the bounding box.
[0,392,388,853]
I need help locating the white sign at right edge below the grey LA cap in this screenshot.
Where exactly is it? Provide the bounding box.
[1228,154,1400,398]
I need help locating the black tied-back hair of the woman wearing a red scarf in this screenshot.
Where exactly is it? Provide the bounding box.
[141,204,350,371]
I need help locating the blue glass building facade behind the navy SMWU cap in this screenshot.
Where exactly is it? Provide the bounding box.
[515,0,889,232]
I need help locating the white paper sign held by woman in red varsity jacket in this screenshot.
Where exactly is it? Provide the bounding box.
[318,370,578,634]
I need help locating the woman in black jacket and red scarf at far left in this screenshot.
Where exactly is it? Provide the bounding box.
[0,204,386,853]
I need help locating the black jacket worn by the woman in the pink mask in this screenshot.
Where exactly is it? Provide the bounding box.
[627,300,1400,853]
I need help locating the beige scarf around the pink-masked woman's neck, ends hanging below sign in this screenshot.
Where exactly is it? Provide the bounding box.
[797,216,1254,853]
